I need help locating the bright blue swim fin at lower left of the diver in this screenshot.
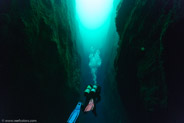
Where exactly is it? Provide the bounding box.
[67,102,82,123]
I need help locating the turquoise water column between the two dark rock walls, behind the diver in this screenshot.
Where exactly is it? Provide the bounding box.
[72,0,121,123]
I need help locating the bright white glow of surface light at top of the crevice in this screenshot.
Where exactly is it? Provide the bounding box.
[76,0,113,29]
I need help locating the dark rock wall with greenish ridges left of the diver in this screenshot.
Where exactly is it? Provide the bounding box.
[0,0,80,123]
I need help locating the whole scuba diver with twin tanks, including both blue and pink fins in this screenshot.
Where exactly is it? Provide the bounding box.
[67,85,101,123]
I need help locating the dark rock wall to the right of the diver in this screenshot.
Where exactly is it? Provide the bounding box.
[115,0,184,123]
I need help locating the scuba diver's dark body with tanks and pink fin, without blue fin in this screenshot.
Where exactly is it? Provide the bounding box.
[83,85,101,116]
